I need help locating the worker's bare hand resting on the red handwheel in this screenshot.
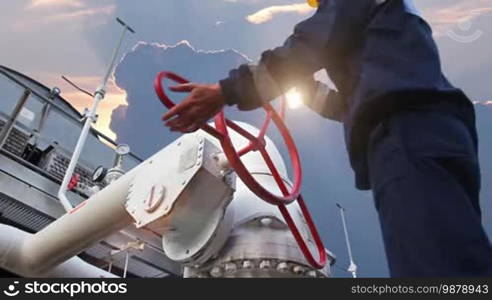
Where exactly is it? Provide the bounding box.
[162,83,225,133]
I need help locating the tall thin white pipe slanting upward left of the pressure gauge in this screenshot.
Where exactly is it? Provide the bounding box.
[58,20,134,212]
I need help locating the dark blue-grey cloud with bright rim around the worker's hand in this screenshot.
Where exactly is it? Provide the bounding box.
[111,41,249,156]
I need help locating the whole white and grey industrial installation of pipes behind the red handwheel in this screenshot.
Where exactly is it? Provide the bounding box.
[0,67,335,277]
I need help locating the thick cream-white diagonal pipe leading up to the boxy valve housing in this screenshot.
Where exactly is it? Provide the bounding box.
[22,168,138,272]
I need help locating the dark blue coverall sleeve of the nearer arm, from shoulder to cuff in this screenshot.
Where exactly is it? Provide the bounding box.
[220,0,375,110]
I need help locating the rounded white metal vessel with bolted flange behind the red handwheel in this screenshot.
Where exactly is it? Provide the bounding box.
[184,122,335,278]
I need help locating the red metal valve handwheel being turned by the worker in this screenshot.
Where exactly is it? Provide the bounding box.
[154,71,327,269]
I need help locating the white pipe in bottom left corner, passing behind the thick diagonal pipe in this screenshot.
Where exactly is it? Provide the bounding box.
[0,224,117,278]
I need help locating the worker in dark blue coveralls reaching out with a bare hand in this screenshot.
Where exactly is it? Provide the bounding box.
[164,0,492,277]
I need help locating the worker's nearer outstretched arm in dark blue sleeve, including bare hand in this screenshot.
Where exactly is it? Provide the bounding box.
[163,0,377,132]
